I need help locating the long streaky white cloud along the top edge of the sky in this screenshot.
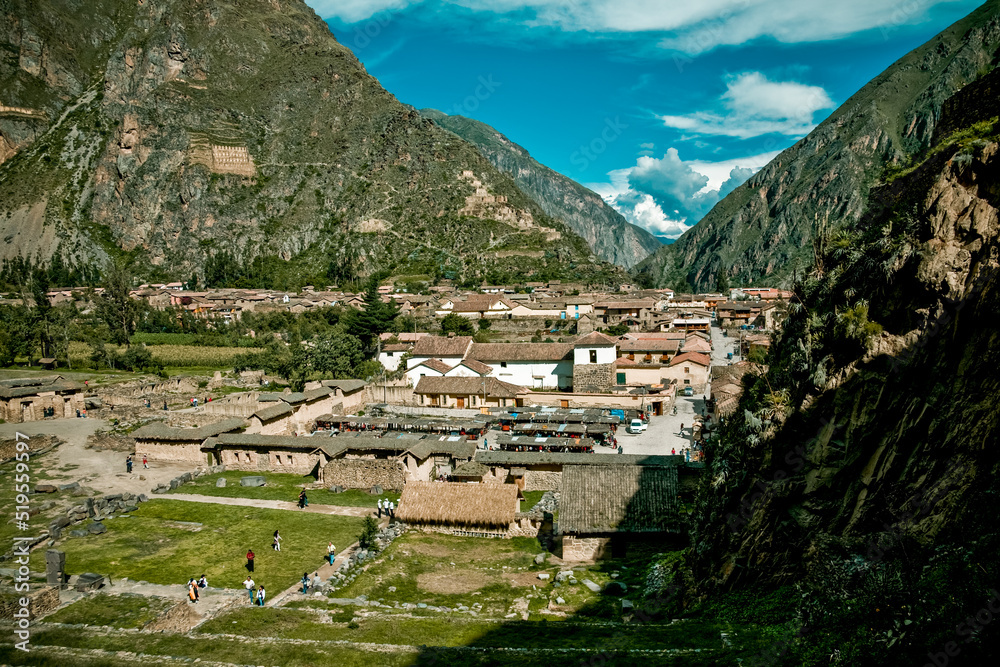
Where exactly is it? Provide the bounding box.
[307,0,958,54]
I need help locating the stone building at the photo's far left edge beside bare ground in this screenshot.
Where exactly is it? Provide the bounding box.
[0,375,84,424]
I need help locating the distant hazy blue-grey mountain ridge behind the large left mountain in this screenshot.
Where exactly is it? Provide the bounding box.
[420,109,662,268]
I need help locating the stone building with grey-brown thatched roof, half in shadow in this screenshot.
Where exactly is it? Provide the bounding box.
[559,465,680,561]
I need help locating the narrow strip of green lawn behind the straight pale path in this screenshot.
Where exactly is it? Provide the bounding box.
[171,471,399,509]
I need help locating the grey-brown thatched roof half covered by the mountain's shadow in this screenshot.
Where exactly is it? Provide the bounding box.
[559,465,677,535]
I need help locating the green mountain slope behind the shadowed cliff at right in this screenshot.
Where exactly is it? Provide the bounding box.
[636,0,1000,290]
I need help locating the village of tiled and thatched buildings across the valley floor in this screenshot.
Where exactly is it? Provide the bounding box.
[0,283,792,664]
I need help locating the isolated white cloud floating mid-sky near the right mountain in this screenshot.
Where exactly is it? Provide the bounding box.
[659,72,834,139]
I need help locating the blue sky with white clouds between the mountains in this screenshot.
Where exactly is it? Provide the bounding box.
[307,0,980,240]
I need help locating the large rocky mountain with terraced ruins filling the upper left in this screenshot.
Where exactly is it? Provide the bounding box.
[0,0,621,284]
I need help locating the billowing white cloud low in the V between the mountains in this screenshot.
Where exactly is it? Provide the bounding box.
[587,148,777,239]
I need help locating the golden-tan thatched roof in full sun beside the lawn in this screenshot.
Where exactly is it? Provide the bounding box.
[396,482,518,527]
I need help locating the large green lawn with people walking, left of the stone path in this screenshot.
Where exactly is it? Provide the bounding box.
[32,499,362,593]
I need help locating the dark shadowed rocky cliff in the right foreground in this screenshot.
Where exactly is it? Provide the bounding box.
[690,70,1000,665]
